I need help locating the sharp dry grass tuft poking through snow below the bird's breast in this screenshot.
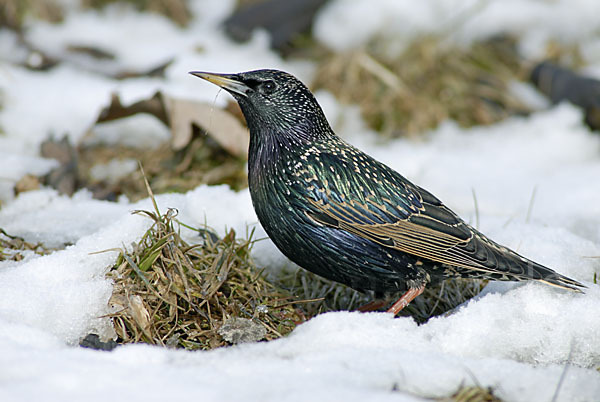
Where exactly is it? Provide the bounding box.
[104,182,304,349]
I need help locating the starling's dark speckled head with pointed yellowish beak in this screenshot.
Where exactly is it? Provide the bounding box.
[190,70,331,142]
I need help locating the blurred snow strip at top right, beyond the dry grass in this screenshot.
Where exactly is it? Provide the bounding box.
[314,0,600,62]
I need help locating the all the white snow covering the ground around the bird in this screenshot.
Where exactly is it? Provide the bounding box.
[0,0,600,401]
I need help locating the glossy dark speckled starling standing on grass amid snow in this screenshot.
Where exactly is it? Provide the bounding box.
[190,70,583,314]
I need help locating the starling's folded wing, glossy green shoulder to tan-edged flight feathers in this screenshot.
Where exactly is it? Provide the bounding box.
[300,149,528,275]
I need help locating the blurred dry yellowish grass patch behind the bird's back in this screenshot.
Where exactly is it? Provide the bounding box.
[313,37,528,137]
